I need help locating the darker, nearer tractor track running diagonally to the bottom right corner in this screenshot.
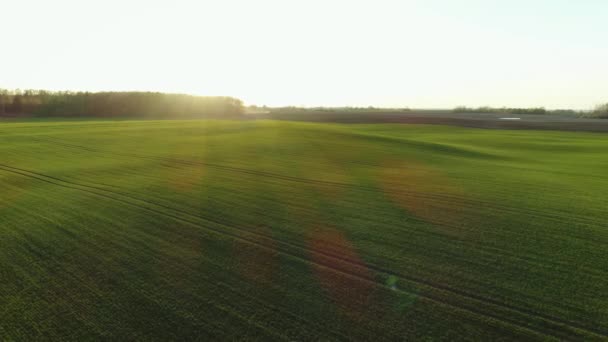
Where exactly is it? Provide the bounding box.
[0,164,608,338]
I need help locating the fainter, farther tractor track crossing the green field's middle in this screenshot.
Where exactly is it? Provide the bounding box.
[30,139,603,232]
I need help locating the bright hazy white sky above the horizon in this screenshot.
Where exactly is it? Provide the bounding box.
[0,0,608,108]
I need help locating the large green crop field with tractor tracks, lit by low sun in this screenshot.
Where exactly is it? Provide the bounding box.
[0,120,608,341]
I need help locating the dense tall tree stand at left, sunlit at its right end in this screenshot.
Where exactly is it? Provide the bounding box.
[0,89,244,118]
